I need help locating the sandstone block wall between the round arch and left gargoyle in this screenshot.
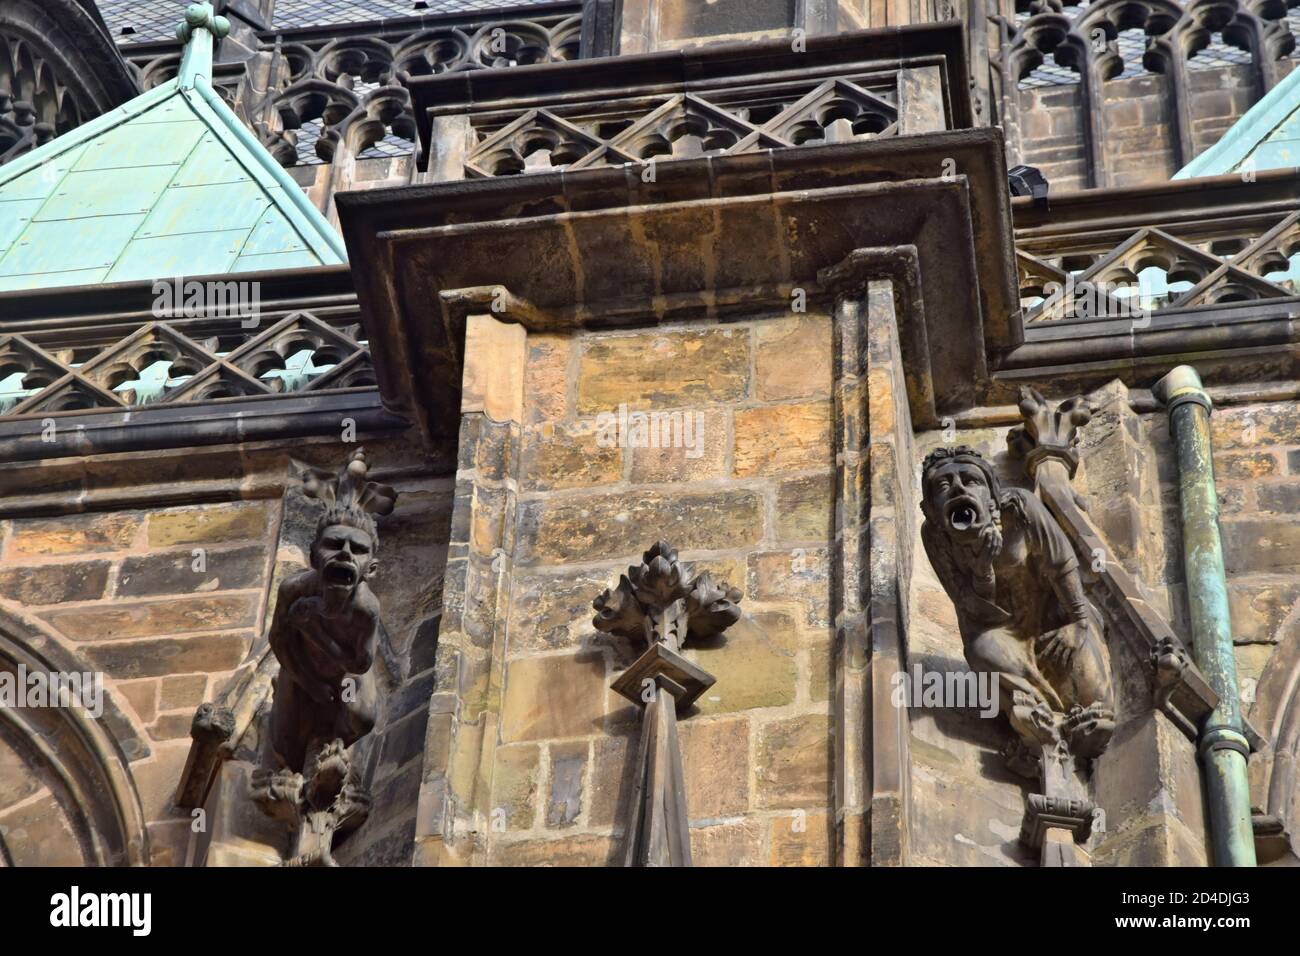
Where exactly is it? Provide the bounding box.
[0,502,276,864]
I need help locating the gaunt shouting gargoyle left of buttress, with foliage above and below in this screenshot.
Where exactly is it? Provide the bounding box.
[254,449,397,866]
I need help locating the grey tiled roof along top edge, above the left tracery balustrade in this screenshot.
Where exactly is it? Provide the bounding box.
[99,0,564,43]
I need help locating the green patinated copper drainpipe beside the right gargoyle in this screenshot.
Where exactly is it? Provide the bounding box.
[1153,365,1255,866]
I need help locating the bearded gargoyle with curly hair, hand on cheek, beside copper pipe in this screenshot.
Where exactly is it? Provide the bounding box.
[920,446,1114,775]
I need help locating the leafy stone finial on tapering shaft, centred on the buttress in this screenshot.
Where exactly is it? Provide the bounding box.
[592,541,742,866]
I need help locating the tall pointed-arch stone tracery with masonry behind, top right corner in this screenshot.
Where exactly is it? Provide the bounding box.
[992,0,1300,190]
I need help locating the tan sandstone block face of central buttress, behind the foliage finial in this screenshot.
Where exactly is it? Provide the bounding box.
[489,315,833,865]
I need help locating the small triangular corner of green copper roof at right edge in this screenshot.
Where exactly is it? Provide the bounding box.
[1174,70,1300,179]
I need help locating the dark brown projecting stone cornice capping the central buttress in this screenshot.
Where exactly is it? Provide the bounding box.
[338,130,1014,436]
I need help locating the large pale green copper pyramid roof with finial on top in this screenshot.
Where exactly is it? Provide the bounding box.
[0,3,346,291]
